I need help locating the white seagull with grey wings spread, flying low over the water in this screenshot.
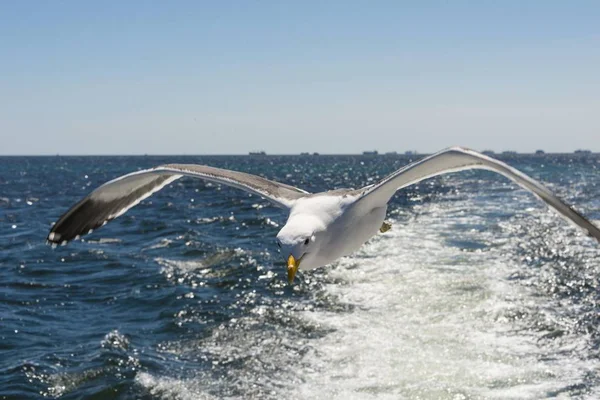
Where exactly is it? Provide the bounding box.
[47,147,600,284]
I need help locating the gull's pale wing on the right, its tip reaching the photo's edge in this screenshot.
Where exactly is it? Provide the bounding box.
[358,147,600,242]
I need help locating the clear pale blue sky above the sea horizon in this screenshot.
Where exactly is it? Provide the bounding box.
[0,0,600,154]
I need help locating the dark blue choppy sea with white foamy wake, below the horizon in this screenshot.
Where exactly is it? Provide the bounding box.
[0,155,600,400]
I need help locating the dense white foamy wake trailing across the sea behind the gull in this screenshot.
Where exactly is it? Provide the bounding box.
[292,204,598,399]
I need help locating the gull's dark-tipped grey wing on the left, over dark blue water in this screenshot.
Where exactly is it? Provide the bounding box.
[48,164,307,244]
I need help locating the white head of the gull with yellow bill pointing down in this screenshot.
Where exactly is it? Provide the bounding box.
[277,214,325,283]
